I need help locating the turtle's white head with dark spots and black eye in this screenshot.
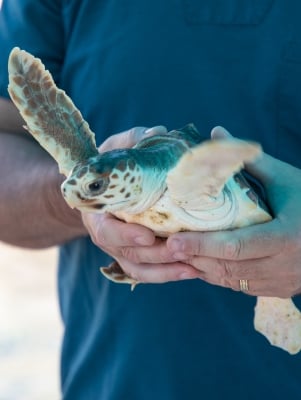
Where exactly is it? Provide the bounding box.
[62,149,142,213]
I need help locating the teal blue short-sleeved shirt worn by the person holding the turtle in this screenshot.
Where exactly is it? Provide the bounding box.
[0,0,301,400]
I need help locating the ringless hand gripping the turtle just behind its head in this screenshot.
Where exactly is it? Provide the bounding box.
[82,126,199,283]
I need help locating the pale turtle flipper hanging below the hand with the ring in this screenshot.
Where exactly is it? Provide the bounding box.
[254,297,301,354]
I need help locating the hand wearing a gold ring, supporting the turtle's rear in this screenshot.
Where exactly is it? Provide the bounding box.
[167,130,301,298]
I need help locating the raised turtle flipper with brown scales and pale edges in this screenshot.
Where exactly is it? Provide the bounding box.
[8,47,98,175]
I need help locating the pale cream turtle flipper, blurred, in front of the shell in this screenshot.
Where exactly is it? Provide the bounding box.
[166,139,261,211]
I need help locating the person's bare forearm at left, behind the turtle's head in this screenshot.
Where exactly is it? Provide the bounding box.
[0,133,86,248]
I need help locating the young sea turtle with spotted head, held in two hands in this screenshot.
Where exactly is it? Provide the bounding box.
[8,48,301,354]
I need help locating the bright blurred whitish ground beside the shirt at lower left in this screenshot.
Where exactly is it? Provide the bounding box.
[0,243,62,400]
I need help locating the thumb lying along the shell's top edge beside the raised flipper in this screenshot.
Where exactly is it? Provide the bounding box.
[98,125,167,153]
